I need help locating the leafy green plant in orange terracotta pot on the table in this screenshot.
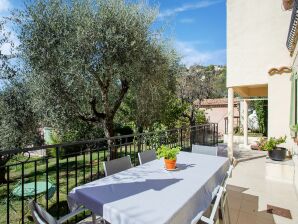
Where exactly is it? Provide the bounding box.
[156,145,181,170]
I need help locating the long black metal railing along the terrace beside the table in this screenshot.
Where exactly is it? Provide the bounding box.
[0,124,218,223]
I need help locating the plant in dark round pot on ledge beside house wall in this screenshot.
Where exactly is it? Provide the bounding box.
[259,136,287,161]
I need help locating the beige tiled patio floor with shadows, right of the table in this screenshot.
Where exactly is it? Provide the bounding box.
[228,158,298,224]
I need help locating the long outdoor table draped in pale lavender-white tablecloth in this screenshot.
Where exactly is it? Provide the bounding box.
[68,152,229,224]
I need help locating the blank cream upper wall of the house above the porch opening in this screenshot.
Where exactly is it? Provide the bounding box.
[227,0,291,87]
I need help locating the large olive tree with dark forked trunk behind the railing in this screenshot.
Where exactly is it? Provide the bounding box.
[15,0,176,157]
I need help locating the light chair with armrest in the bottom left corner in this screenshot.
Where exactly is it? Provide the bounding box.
[29,200,89,224]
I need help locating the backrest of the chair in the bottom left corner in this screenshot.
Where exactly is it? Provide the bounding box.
[29,200,58,224]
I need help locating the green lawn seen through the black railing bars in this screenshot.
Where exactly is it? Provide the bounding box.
[0,152,104,223]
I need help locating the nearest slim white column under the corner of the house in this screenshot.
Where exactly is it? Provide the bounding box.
[228,88,234,161]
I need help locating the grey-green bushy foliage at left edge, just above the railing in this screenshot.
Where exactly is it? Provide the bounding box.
[0,80,41,150]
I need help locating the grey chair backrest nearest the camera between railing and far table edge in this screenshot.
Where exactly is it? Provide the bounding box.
[103,156,132,176]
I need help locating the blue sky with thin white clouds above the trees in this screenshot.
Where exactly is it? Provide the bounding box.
[0,0,226,66]
